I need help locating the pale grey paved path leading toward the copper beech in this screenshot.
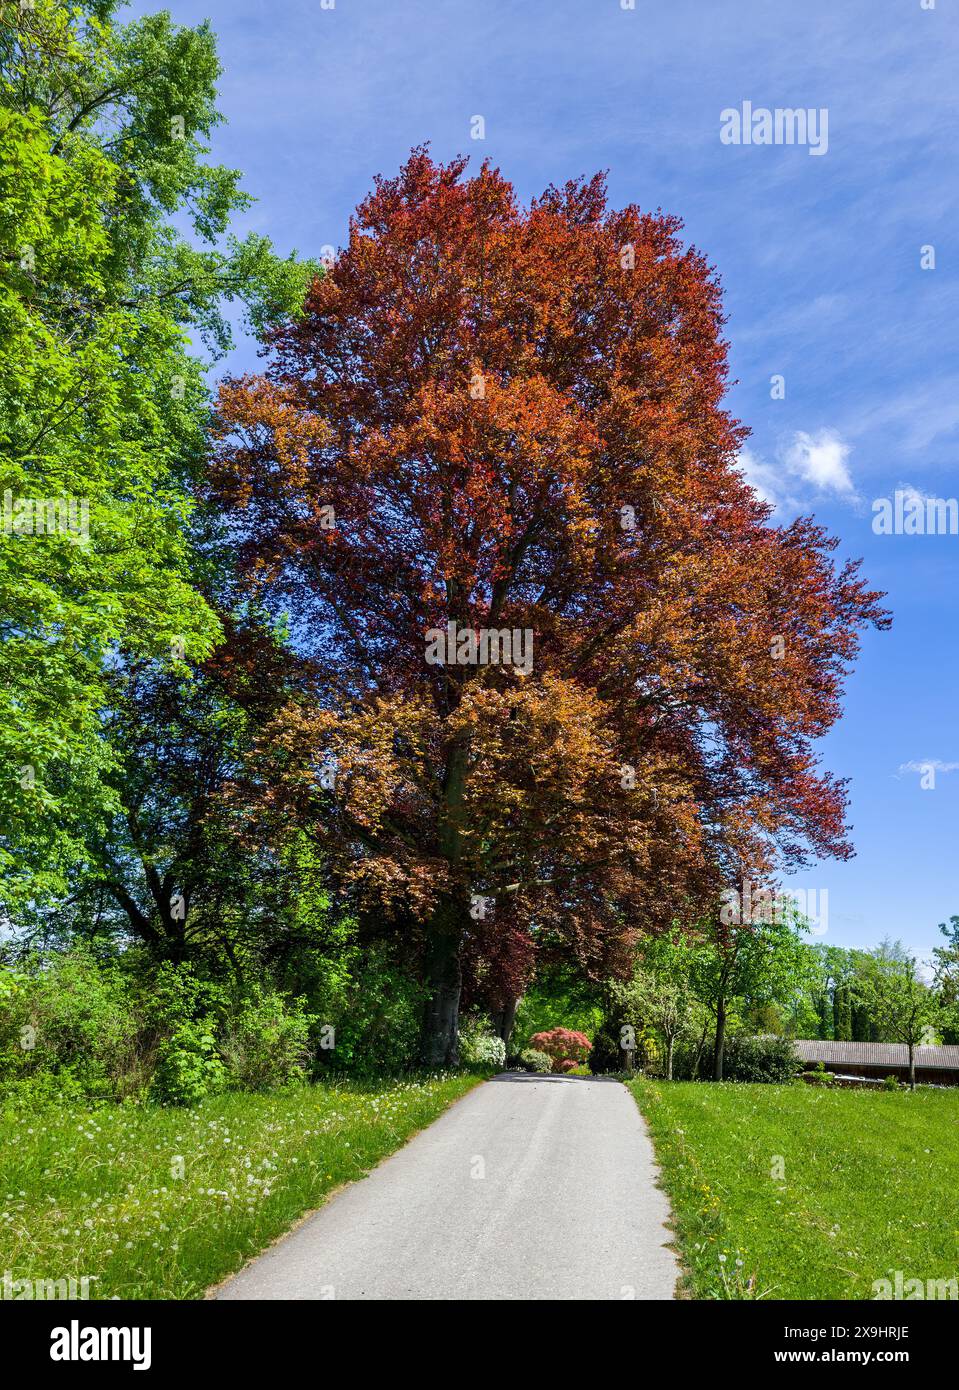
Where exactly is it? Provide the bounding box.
[215,1073,677,1300]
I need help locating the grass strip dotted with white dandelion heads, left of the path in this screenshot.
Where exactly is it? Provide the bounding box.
[0,1076,480,1298]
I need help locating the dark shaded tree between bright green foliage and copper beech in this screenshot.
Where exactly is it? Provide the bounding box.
[54,623,298,977]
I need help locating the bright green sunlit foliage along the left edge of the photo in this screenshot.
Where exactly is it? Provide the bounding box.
[0,0,310,905]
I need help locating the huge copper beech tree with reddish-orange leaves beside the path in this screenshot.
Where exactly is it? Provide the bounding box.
[210,150,888,1063]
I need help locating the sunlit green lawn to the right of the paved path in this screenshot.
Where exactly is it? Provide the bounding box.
[630,1080,959,1298]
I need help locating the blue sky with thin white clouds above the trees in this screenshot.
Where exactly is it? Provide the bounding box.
[128,0,959,958]
